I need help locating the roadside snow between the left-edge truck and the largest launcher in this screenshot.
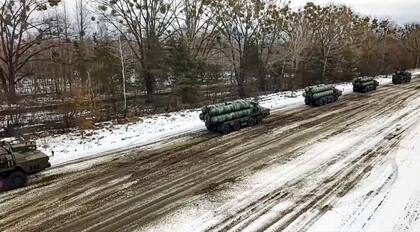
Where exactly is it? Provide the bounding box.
[37,111,205,166]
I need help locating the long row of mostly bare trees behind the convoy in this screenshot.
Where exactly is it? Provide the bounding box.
[0,0,420,124]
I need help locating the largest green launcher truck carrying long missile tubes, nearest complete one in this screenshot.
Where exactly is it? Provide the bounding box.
[200,100,270,134]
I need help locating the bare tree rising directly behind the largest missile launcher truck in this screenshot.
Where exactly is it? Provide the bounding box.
[212,0,286,97]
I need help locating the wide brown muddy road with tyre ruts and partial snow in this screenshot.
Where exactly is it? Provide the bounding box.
[0,81,420,231]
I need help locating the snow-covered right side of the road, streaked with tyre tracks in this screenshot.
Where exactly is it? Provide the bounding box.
[139,82,420,232]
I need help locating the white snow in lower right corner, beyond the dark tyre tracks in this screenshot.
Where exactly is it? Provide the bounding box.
[310,120,420,232]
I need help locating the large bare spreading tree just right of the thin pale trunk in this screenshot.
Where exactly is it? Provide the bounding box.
[98,0,180,102]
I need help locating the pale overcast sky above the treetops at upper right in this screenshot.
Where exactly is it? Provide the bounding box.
[291,0,420,25]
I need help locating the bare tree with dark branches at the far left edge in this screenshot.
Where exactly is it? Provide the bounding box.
[0,0,59,103]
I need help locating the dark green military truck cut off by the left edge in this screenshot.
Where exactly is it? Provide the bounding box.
[0,142,51,190]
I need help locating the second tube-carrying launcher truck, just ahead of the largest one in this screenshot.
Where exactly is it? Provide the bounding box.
[303,85,343,106]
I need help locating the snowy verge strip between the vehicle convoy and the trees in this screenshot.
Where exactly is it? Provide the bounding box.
[30,71,416,166]
